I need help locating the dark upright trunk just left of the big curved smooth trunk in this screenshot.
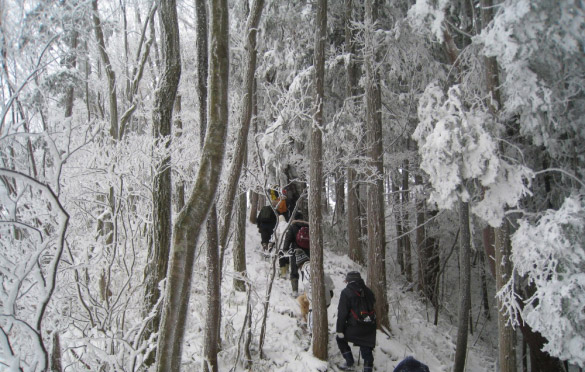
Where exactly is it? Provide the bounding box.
[145,1,181,365]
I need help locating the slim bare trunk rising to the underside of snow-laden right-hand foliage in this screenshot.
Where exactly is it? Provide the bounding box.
[453,201,471,372]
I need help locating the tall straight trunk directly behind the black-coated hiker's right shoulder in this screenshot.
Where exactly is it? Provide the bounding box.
[364,0,390,330]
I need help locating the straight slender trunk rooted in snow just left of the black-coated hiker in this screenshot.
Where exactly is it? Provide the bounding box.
[309,0,329,360]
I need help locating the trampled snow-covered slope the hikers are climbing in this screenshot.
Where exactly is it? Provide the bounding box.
[183,222,496,372]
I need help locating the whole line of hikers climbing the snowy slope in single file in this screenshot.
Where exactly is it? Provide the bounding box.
[256,187,429,372]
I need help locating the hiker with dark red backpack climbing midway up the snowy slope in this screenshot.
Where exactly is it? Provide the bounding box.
[278,212,311,298]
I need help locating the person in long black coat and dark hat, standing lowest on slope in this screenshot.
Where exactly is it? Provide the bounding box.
[335,271,376,372]
